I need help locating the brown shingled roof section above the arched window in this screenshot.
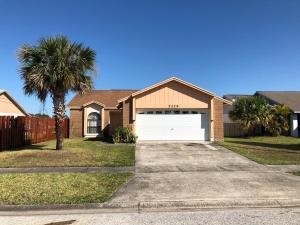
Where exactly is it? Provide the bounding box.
[67,90,137,108]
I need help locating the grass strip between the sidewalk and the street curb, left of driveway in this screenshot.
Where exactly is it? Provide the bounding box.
[0,173,131,205]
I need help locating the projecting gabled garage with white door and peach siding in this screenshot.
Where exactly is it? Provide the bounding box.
[117,77,231,141]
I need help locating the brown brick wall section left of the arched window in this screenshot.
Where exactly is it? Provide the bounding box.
[70,109,83,138]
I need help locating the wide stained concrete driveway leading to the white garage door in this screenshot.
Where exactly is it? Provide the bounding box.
[109,142,300,207]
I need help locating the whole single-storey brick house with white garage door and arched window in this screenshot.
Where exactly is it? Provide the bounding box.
[67,77,231,140]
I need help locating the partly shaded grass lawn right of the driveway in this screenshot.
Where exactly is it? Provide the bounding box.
[219,136,300,165]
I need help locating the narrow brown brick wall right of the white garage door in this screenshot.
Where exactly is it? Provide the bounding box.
[213,99,224,141]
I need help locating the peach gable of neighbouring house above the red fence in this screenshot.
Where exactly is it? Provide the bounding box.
[0,90,28,117]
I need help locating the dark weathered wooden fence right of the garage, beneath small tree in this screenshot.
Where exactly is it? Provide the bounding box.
[224,123,262,137]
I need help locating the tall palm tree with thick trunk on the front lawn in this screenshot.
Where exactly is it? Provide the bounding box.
[18,36,96,150]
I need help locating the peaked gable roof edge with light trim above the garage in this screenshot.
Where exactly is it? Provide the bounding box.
[118,77,231,105]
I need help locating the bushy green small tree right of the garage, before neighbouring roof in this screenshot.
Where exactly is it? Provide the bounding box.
[229,96,270,130]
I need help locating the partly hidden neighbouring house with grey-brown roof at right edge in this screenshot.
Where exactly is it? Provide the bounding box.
[254,91,300,137]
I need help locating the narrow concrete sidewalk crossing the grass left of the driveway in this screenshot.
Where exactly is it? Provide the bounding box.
[0,167,134,173]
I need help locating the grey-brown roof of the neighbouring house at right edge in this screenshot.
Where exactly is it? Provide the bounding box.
[255,91,300,113]
